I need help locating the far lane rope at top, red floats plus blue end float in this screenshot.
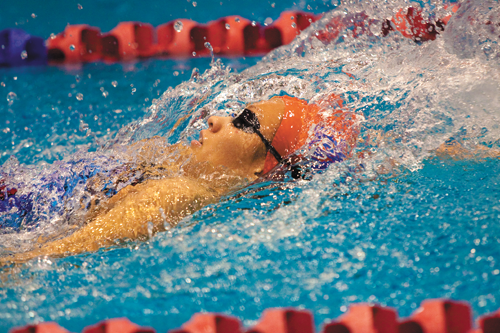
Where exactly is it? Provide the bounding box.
[0,4,459,66]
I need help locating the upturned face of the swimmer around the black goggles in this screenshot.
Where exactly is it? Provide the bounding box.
[191,98,285,178]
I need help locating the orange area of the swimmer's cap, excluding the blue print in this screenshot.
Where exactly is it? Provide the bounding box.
[263,94,359,174]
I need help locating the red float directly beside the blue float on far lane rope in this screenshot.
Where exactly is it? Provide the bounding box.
[47,24,102,63]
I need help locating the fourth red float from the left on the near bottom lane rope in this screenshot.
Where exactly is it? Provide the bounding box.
[246,309,314,333]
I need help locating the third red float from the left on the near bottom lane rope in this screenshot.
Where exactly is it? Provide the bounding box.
[169,313,243,333]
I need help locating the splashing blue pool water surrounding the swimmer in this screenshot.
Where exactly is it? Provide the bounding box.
[0,1,500,332]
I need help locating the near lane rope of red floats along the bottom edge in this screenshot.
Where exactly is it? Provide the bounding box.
[10,299,500,333]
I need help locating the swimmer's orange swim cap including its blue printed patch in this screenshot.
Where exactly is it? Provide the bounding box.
[263,94,359,174]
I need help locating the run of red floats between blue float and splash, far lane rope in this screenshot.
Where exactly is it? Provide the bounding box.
[47,11,321,63]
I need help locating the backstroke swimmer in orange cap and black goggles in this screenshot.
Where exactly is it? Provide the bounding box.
[2,95,359,262]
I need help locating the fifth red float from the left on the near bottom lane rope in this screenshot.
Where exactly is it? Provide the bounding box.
[340,304,397,333]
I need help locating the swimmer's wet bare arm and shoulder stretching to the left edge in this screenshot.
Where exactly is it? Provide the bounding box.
[5,178,219,262]
